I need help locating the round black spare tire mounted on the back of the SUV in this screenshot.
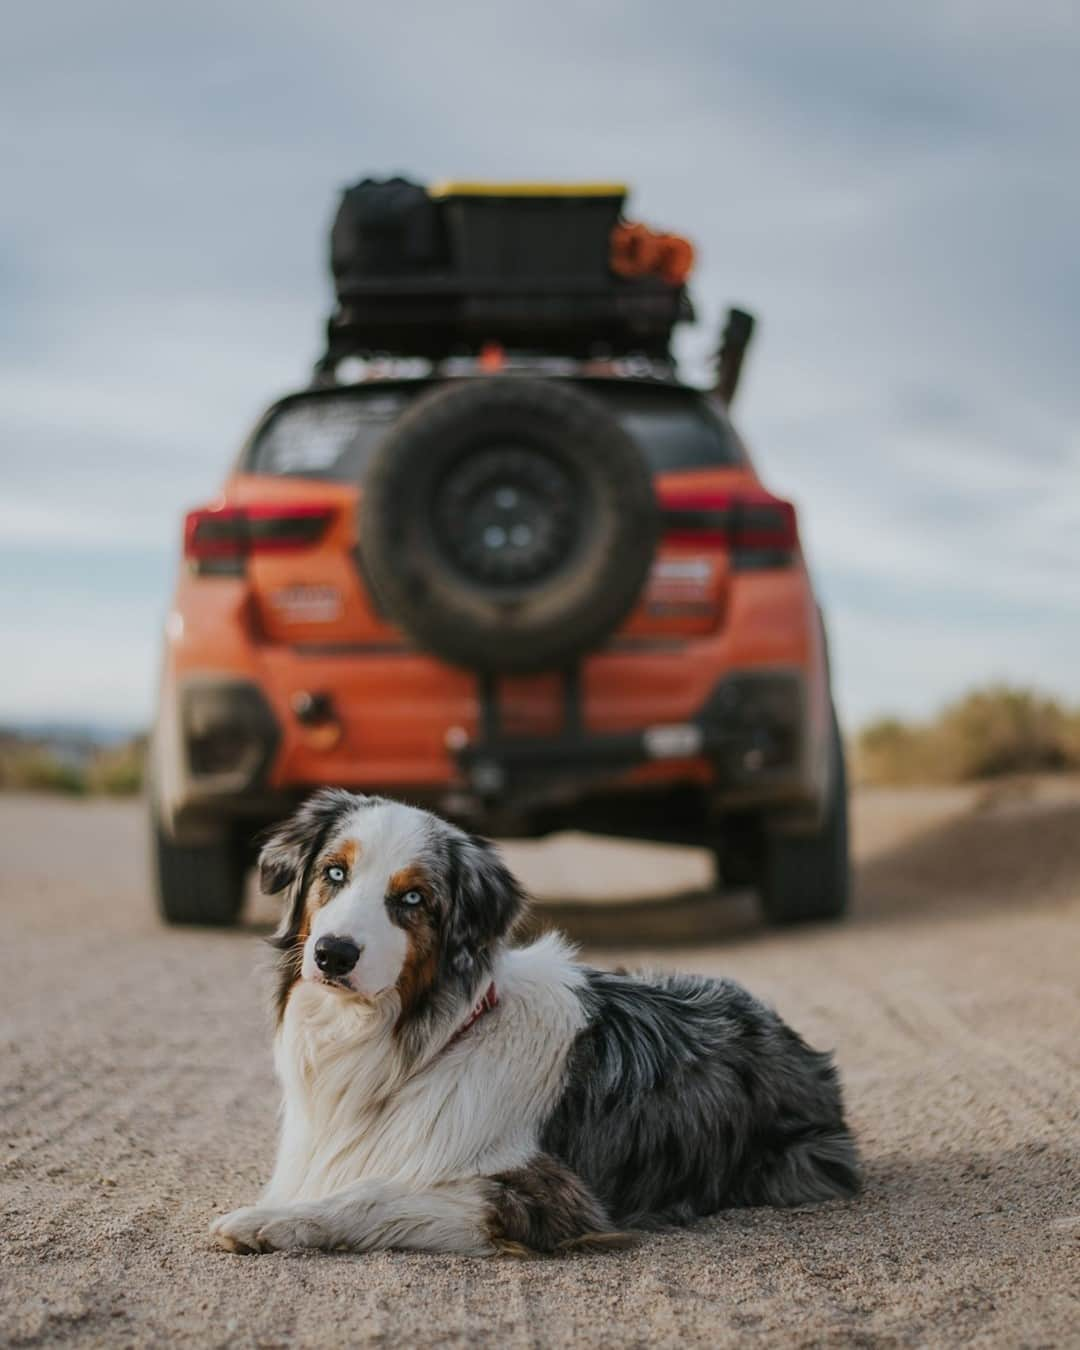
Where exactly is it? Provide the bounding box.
[360,377,659,672]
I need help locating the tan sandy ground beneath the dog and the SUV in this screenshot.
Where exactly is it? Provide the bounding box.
[0,784,1080,1350]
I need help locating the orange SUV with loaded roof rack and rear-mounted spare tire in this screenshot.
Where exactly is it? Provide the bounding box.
[149,180,848,923]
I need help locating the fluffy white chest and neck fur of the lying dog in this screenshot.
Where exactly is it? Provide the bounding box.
[263,936,585,1204]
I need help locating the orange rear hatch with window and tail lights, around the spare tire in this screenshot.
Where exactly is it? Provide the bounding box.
[186,379,795,653]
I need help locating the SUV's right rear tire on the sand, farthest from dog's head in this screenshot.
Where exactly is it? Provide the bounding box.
[757,714,851,925]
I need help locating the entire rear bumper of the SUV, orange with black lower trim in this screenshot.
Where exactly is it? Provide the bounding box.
[154,558,830,832]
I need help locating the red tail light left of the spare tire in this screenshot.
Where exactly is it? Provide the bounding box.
[184,504,333,574]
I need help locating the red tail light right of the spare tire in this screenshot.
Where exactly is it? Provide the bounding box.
[660,489,799,570]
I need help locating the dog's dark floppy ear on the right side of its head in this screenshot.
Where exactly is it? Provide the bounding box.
[443,834,525,979]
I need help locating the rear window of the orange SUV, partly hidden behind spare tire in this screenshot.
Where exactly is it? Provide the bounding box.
[247,382,741,481]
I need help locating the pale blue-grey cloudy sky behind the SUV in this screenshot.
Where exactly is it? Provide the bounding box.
[0,0,1080,726]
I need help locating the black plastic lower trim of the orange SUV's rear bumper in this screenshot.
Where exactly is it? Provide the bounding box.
[155,670,824,832]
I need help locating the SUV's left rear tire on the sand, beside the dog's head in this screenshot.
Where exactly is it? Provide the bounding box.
[150,813,247,927]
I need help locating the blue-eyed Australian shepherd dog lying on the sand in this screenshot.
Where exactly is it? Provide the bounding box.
[211,788,859,1257]
